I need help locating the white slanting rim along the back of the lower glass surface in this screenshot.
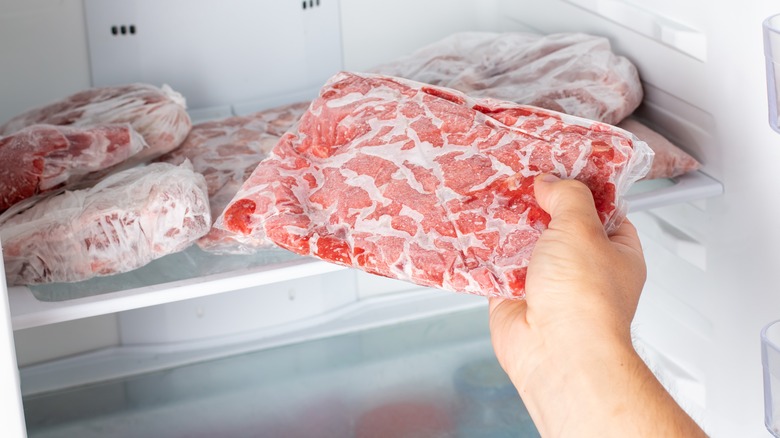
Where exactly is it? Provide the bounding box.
[20,288,487,397]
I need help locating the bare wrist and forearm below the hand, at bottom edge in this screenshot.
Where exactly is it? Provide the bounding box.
[510,337,705,437]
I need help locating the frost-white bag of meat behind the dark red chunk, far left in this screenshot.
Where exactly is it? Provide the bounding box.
[0,84,192,162]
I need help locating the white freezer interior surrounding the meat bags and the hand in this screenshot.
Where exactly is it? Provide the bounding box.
[0,0,780,436]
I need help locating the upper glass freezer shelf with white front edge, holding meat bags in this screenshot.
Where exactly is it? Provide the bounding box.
[9,172,723,330]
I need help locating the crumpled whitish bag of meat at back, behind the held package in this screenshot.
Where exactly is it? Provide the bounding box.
[371,32,643,125]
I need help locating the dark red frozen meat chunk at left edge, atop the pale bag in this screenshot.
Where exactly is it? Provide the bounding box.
[0,124,146,211]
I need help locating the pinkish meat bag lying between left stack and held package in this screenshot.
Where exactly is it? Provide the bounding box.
[159,102,309,254]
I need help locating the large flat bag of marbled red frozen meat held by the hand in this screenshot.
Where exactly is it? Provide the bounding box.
[215,72,653,298]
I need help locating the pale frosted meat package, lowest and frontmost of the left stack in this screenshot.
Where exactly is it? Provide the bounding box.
[0,163,211,285]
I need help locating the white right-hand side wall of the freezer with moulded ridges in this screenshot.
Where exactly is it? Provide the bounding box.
[501,0,780,437]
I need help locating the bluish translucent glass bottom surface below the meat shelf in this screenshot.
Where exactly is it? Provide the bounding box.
[24,306,539,438]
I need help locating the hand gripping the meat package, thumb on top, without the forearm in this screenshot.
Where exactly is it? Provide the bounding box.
[490,175,646,383]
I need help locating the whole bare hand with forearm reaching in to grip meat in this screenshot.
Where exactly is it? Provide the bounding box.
[489,176,704,437]
